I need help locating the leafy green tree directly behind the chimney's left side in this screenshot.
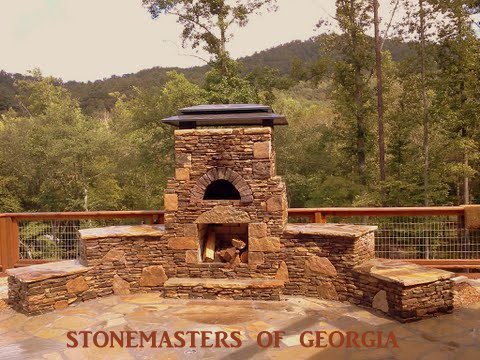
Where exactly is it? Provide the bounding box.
[109,72,207,209]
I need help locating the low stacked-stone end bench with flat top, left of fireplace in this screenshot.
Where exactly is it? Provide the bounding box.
[7,260,96,315]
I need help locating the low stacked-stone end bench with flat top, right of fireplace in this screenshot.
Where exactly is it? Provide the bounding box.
[352,259,455,322]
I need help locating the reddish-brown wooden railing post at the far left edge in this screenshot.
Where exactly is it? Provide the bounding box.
[0,217,20,271]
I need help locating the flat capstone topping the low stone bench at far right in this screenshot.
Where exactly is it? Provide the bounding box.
[354,259,455,286]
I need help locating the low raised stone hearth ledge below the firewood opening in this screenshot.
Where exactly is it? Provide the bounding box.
[164,278,284,300]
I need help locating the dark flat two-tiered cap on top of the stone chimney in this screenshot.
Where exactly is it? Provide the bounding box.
[162,104,288,129]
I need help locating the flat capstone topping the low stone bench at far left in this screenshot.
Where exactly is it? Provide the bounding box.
[6,260,91,283]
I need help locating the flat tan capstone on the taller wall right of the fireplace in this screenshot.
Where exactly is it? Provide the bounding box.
[284,224,377,239]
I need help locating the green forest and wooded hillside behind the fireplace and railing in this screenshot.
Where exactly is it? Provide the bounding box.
[0,0,480,212]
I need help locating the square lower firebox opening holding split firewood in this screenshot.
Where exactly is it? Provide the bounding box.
[199,224,248,266]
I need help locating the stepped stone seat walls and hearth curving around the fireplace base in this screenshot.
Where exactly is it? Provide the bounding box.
[8,224,453,321]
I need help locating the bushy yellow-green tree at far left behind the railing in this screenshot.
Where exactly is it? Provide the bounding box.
[0,71,120,211]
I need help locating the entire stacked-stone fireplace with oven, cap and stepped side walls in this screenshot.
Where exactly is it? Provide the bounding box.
[8,105,453,321]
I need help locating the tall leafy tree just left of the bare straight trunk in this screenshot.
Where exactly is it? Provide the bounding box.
[319,0,373,185]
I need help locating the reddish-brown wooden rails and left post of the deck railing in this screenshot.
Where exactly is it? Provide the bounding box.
[0,206,480,272]
